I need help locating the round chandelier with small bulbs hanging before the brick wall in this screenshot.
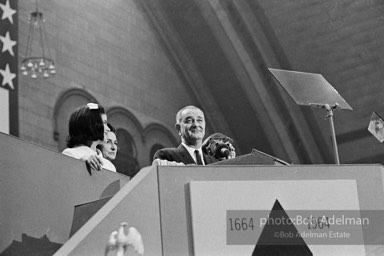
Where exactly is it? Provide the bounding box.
[20,0,56,78]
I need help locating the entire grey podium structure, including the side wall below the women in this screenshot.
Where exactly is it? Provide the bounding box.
[0,134,384,256]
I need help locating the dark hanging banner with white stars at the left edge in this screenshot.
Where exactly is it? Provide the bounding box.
[0,0,19,136]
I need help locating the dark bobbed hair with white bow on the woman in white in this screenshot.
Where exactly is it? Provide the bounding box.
[67,103,105,148]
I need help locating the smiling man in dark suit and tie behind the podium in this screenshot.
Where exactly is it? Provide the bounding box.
[153,106,217,165]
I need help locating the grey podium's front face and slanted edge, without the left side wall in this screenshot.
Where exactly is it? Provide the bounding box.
[55,165,384,255]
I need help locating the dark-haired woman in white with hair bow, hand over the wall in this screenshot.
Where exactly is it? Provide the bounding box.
[63,103,116,173]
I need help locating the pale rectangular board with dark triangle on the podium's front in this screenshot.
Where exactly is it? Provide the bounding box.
[190,180,365,256]
